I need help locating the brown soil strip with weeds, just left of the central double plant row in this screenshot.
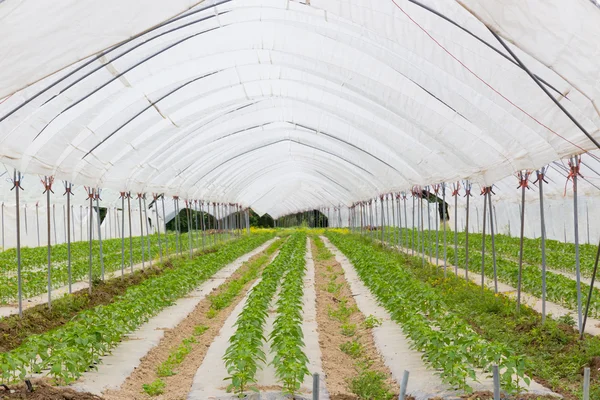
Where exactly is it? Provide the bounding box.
[103,245,276,400]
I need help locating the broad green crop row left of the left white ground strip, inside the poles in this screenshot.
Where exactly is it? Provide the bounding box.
[0,234,272,383]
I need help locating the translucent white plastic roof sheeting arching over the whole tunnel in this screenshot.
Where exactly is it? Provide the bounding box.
[0,0,600,217]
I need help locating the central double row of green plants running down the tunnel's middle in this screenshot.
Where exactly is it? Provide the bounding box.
[223,232,307,395]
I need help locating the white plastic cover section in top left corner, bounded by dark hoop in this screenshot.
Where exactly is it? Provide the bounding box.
[0,0,203,98]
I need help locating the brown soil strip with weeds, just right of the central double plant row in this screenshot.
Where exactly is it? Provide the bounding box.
[311,240,400,400]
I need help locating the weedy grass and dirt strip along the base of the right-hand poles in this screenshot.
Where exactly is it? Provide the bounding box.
[382,234,600,399]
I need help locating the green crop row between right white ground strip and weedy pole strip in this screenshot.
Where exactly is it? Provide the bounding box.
[327,232,528,391]
